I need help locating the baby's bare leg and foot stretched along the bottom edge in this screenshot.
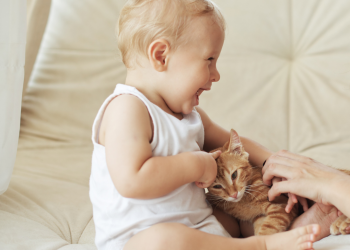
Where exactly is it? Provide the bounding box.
[124,223,319,250]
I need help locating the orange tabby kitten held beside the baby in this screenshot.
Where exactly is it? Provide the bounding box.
[206,129,350,235]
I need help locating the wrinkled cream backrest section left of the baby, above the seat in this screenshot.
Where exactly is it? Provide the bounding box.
[21,0,126,148]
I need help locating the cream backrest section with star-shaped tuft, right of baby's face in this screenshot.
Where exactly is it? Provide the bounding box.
[204,0,350,169]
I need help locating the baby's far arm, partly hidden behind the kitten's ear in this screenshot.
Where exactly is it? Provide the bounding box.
[196,106,272,166]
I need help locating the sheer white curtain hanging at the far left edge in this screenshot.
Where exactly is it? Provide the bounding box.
[0,0,26,195]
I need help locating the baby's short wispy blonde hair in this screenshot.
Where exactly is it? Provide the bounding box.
[117,0,226,68]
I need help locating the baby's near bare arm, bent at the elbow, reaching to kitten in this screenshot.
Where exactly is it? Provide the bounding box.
[101,95,216,199]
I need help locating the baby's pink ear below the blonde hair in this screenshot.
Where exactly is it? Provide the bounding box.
[148,39,170,72]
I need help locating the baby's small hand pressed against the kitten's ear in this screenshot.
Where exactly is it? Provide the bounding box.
[195,150,221,188]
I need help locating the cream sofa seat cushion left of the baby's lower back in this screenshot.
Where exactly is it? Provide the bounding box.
[0,146,96,250]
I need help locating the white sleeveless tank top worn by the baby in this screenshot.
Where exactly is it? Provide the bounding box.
[90,84,212,249]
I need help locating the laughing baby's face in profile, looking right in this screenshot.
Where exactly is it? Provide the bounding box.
[163,16,225,114]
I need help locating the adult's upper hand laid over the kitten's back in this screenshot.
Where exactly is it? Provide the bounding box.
[262,150,343,205]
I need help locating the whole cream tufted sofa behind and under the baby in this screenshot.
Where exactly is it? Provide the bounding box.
[0,0,350,250]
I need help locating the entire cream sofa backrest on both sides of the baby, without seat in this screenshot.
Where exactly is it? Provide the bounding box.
[20,0,350,168]
